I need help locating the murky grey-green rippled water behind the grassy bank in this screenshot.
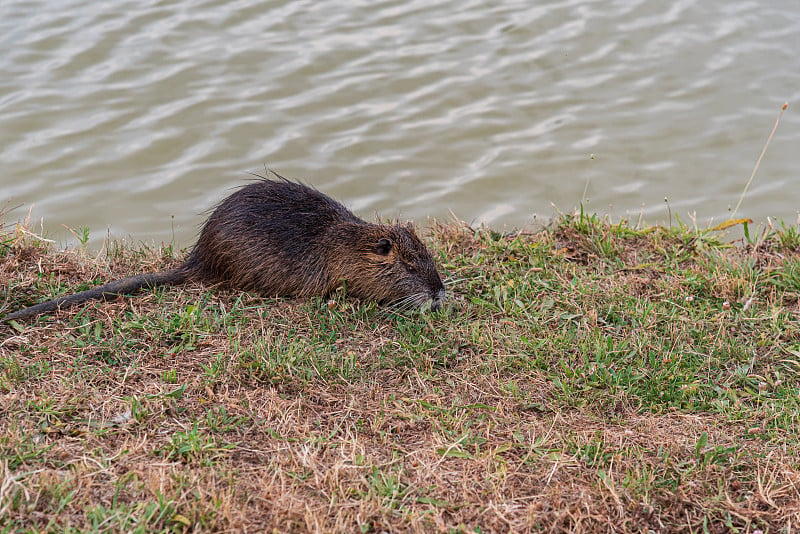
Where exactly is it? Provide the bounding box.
[0,0,800,246]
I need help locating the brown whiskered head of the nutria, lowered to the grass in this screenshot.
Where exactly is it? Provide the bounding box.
[328,223,445,310]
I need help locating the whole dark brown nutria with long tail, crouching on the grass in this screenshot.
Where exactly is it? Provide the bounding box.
[4,174,445,321]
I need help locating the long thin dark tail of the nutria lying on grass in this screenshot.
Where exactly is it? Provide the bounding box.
[2,268,189,322]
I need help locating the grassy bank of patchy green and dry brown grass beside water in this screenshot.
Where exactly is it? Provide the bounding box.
[0,214,800,532]
